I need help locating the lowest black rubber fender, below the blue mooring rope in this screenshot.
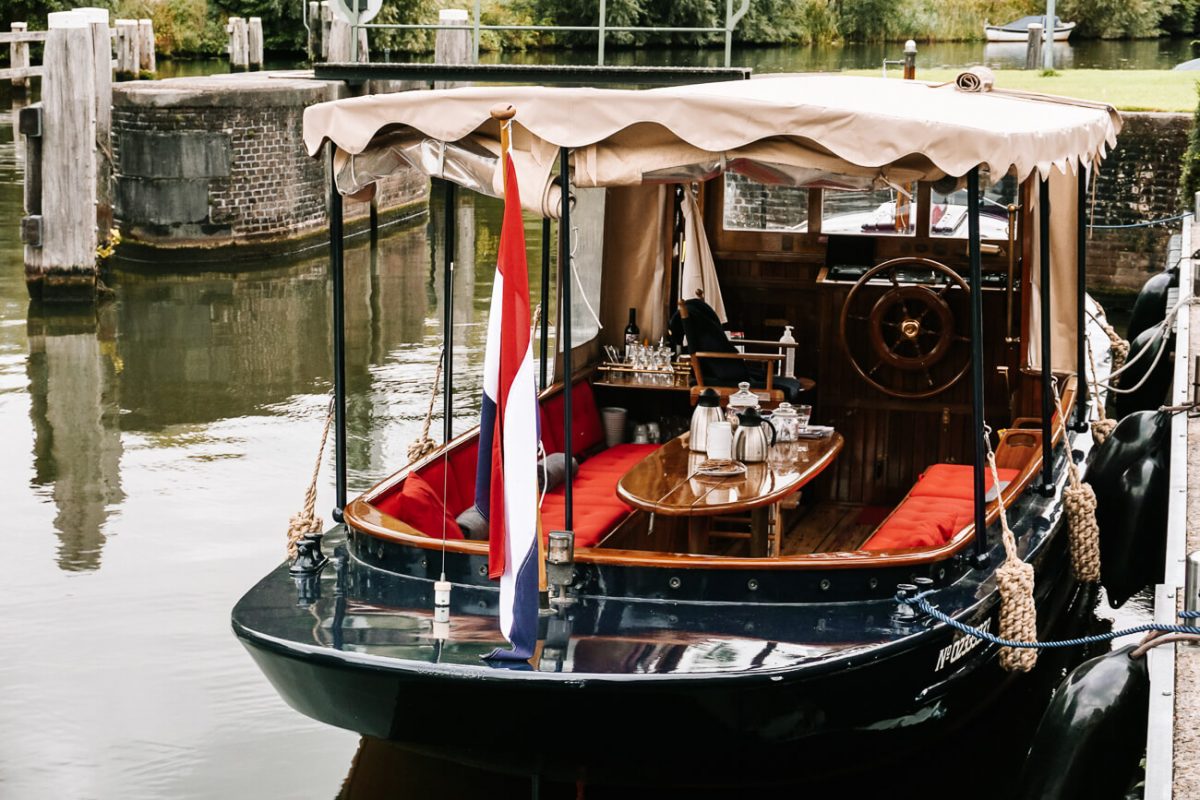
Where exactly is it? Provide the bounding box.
[1016,645,1150,800]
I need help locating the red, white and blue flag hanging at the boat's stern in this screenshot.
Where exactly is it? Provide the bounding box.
[475,158,541,661]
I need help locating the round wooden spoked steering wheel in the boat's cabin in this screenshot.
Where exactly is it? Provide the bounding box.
[839,258,971,399]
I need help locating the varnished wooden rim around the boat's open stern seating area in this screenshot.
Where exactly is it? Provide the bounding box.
[344,381,1074,571]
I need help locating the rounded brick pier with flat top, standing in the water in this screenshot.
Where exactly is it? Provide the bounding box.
[113,73,427,252]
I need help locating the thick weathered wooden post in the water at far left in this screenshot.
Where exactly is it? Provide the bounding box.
[25,12,98,300]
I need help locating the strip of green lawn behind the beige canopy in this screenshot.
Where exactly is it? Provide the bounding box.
[851,66,1200,112]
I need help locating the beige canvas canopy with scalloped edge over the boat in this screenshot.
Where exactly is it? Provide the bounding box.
[304,76,1121,216]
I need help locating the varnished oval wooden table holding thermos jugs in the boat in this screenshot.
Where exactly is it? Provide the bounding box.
[617,432,845,558]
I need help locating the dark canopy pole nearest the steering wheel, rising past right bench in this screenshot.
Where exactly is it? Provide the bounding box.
[967,167,989,567]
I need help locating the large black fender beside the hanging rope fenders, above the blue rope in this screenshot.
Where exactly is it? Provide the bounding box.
[1084,411,1171,608]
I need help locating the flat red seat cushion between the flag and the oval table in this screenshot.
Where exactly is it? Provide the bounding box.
[541,444,659,547]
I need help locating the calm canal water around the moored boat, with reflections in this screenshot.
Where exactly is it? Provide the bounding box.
[0,47,1145,800]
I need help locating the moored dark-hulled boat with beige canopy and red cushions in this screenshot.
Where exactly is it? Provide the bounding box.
[232,76,1121,775]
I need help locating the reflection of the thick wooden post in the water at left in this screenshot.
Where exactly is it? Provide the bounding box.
[26,305,125,572]
